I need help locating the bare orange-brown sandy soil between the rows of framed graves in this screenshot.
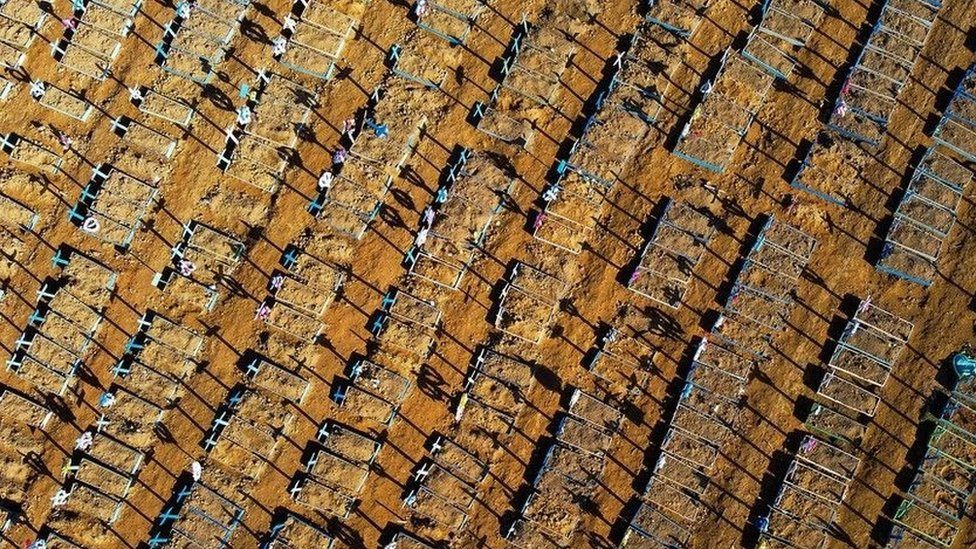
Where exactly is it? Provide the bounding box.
[0,0,976,549]
